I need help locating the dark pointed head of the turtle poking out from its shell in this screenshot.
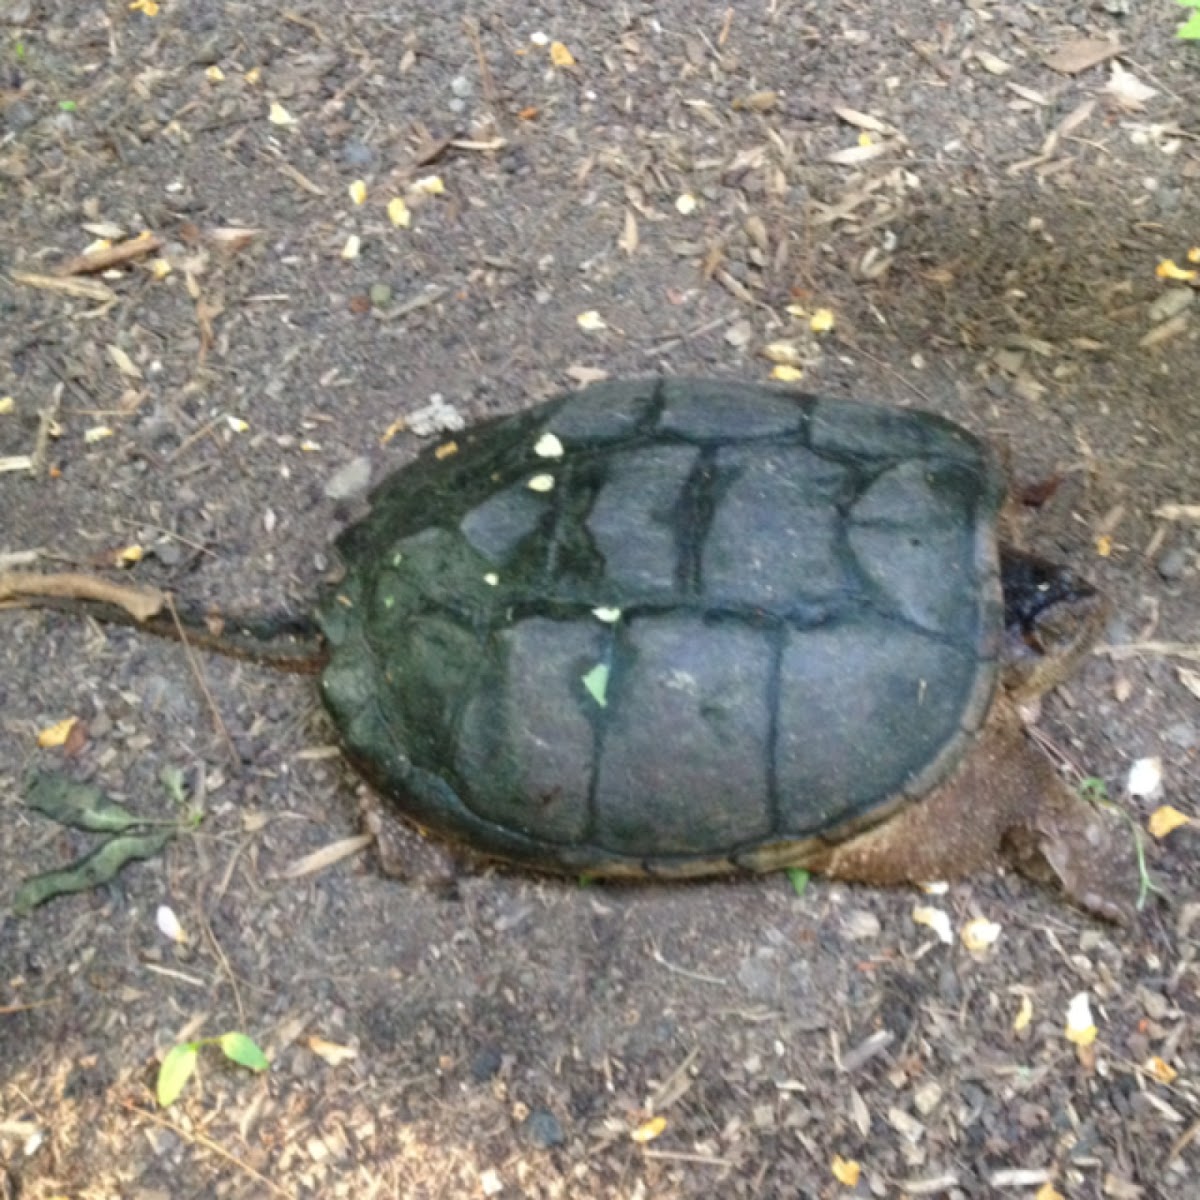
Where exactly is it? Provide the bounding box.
[1000,546,1109,701]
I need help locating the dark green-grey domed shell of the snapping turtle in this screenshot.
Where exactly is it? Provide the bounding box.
[318,379,1003,875]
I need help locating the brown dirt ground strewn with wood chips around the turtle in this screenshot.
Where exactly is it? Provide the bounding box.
[0,0,1200,1200]
